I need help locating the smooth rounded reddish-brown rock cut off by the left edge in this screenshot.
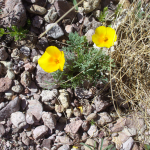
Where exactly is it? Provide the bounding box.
[0,77,12,92]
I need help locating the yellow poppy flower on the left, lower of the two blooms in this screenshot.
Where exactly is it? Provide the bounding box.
[38,46,65,73]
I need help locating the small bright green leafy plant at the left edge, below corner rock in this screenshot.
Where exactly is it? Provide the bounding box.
[0,26,28,41]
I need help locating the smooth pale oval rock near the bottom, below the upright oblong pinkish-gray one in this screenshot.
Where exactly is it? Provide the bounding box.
[33,125,48,139]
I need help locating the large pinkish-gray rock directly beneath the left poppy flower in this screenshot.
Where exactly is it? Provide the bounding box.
[36,65,59,89]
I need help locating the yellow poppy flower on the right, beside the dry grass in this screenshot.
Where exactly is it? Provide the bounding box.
[92,26,117,48]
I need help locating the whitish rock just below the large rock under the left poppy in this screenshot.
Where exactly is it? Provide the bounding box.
[40,89,58,102]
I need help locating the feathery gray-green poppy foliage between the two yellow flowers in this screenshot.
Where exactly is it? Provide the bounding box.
[52,32,113,88]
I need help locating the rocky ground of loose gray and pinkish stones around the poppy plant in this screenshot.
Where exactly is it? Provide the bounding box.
[0,0,150,150]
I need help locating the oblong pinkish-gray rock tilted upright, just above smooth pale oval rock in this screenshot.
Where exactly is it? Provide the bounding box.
[42,112,56,130]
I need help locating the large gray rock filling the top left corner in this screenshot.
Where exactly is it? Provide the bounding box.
[0,0,27,27]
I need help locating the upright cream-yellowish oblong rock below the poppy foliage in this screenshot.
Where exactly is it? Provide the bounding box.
[58,90,69,108]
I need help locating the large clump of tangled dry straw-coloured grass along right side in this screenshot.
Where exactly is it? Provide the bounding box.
[112,1,150,143]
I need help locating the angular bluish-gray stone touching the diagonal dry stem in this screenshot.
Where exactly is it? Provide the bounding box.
[46,23,64,39]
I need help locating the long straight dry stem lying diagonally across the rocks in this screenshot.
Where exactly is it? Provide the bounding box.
[39,0,84,38]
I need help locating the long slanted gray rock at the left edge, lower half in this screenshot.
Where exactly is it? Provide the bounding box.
[0,97,20,121]
